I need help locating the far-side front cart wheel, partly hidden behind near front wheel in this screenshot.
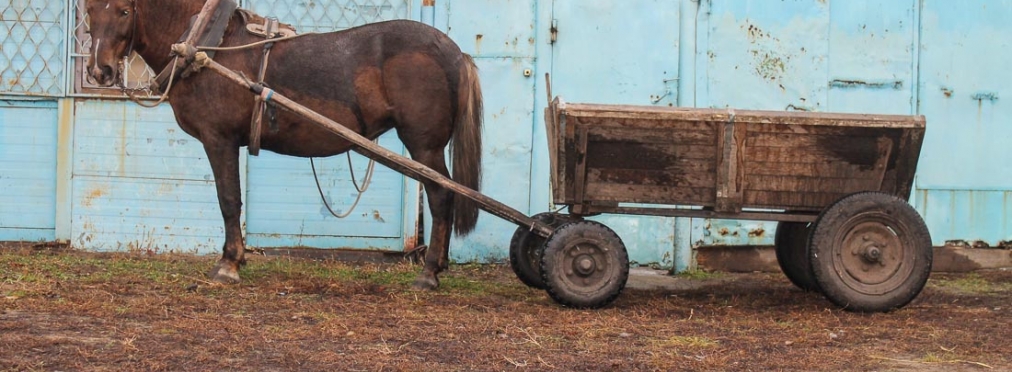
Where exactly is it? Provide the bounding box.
[509,212,568,289]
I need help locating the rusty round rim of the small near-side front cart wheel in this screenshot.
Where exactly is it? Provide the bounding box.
[559,239,615,293]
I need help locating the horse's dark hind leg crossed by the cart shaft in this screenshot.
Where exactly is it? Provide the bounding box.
[413,149,453,289]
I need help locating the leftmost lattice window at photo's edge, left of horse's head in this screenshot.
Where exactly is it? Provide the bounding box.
[0,0,67,96]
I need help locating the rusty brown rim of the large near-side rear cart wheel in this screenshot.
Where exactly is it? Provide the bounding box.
[833,212,914,295]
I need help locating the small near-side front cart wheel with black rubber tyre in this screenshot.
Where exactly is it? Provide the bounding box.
[541,220,629,308]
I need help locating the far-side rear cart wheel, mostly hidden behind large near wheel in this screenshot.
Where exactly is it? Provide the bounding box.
[773,222,819,291]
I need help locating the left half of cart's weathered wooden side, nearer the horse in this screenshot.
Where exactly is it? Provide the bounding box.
[570,116,716,206]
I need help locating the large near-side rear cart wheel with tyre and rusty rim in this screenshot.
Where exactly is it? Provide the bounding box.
[809,192,932,311]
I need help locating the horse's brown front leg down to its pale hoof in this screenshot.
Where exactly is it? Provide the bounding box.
[203,138,246,283]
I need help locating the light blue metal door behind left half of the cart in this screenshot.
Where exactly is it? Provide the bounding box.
[537,0,680,266]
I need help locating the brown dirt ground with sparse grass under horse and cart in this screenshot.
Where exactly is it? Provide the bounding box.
[0,244,1012,371]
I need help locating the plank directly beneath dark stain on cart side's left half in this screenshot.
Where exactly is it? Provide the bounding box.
[587,168,716,187]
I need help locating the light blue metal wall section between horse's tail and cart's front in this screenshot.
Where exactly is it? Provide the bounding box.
[445,0,535,262]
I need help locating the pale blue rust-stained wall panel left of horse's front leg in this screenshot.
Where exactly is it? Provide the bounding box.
[71,100,225,253]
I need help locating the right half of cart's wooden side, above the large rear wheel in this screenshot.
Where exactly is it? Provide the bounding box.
[744,123,916,211]
